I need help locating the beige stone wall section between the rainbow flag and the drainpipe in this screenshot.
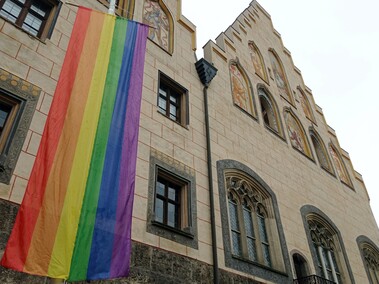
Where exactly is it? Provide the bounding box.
[132,1,215,263]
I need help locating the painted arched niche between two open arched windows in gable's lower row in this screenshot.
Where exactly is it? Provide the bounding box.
[284,109,312,158]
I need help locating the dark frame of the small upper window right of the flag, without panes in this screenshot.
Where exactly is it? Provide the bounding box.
[157,71,189,128]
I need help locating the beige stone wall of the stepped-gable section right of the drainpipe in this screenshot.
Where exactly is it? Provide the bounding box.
[204,1,379,283]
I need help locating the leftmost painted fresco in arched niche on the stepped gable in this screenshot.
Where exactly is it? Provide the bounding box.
[230,64,252,114]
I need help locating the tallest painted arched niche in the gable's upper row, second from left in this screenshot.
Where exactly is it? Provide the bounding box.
[269,50,293,104]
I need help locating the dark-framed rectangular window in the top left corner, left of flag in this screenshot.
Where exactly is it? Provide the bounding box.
[0,0,60,40]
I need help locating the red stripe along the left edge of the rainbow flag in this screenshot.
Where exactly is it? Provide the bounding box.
[1,9,91,271]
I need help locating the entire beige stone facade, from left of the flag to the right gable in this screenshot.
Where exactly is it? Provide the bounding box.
[0,0,379,283]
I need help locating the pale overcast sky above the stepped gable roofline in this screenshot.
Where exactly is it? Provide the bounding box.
[182,0,379,226]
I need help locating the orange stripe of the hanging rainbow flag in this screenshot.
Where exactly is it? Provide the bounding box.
[24,13,104,275]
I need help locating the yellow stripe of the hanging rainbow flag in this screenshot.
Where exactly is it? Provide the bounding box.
[48,13,116,279]
